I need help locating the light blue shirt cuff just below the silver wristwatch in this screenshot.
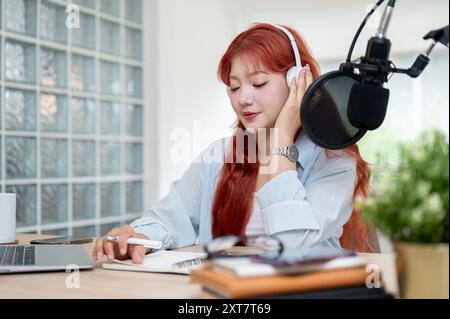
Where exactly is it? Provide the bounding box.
[256,171,306,209]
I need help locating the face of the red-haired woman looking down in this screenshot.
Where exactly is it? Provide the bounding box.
[227,56,289,130]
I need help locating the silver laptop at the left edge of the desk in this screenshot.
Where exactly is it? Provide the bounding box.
[0,245,94,274]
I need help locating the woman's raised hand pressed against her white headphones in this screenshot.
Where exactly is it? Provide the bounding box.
[275,64,313,146]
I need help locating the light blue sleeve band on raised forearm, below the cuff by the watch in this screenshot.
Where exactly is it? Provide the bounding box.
[261,200,320,235]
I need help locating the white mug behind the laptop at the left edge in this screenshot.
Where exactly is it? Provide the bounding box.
[0,193,16,244]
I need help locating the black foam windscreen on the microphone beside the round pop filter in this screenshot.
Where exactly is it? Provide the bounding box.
[347,83,389,130]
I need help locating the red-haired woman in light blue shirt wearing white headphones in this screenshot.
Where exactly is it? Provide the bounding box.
[93,23,374,263]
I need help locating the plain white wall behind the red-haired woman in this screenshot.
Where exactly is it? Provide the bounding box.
[146,0,449,202]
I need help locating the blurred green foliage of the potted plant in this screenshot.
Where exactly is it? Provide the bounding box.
[358,131,449,243]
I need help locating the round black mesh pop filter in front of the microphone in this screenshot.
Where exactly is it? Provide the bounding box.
[300,71,367,150]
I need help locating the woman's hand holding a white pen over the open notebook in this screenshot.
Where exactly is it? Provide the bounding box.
[92,225,149,264]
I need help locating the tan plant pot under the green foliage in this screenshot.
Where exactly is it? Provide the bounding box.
[395,242,449,299]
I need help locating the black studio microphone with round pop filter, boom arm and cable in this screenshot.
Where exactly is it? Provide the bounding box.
[300,0,449,150]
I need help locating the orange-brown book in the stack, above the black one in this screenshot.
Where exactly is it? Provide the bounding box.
[190,267,368,298]
